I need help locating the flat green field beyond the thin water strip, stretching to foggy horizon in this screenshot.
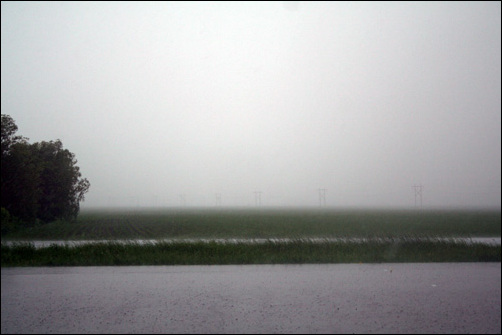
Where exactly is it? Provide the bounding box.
[2,209,501,240]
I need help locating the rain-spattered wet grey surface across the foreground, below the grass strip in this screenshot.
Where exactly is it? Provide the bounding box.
[1,263,501,334]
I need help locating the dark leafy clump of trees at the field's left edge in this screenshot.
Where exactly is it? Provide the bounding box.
[1,114,90,226]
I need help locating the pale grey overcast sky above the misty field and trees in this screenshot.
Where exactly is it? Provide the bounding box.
[1,1,501,209]
